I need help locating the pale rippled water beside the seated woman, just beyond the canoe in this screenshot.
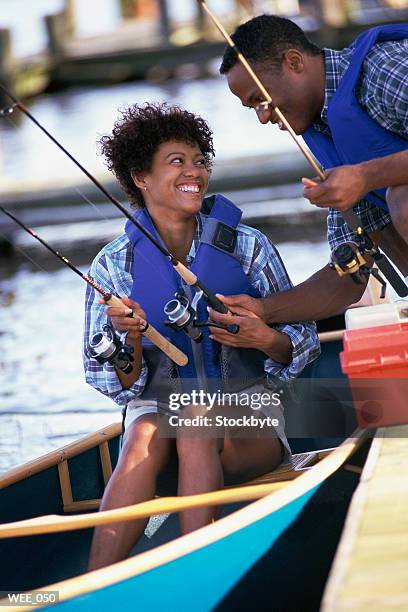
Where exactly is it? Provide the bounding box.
[0,237,328,471]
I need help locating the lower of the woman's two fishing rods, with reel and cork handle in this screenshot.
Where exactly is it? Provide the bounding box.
[0,205,188,373]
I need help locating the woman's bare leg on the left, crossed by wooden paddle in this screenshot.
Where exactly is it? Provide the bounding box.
[88,414,173,571]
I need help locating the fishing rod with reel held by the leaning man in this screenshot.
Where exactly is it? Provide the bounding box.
[197,0,408,297]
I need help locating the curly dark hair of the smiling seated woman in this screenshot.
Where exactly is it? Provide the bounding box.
[99,102,214,208]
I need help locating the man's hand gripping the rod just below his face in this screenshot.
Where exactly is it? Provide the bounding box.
[302,164,370,211]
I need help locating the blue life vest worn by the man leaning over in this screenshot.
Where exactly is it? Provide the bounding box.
[302,24,408,210]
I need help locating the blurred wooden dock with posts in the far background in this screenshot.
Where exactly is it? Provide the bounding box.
[0,0,408,102]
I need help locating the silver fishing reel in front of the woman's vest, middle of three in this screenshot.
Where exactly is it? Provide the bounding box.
[164,290,239,342]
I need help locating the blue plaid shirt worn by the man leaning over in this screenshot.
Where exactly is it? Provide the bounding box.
[314,39,408,250]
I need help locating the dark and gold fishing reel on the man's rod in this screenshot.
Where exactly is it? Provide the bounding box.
[329,239,387,298]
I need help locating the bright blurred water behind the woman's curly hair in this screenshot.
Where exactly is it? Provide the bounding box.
[0,77,296,191]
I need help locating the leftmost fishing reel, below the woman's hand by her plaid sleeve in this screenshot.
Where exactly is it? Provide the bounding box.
[90,323,134,374]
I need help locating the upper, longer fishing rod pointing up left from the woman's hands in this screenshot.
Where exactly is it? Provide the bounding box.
[0,83,239,334]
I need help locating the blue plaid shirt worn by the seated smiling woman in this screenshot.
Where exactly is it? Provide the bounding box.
[83,213,320,406]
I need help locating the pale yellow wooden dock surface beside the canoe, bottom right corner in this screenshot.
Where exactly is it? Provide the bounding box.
[322,425,408,612]
